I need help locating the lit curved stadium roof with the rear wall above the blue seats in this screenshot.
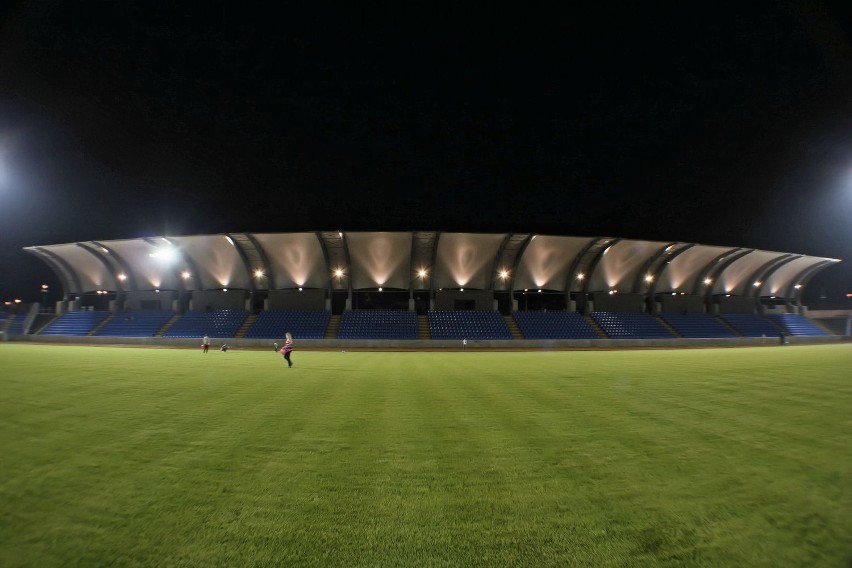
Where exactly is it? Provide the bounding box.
[24,231,839,314]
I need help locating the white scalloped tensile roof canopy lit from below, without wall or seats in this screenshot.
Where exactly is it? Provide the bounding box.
[24,231,840,300]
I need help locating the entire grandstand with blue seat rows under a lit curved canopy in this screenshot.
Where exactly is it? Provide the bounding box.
[8,231,838,345]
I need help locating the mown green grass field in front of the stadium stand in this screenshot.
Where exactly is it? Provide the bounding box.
[0,343,852,568]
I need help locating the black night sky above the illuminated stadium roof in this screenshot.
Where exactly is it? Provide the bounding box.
[0,0,852,306]
